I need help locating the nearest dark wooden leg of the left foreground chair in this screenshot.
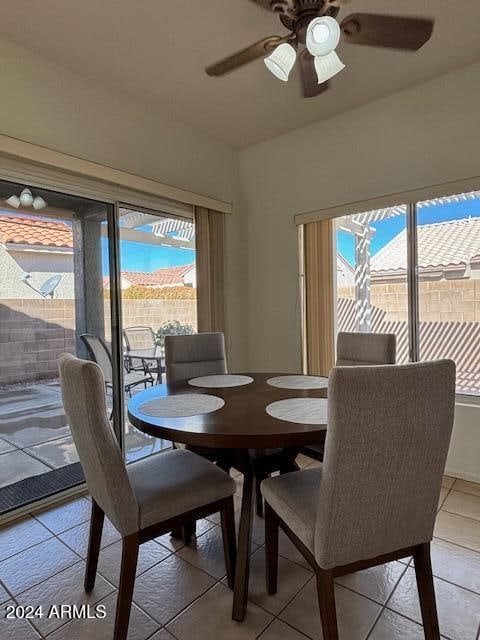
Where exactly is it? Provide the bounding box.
[113,533,138,640]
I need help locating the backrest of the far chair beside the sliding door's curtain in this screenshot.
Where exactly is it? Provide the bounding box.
[165,332,227,383]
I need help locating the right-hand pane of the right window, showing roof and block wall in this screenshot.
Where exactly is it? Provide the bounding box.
[417,191,480,395]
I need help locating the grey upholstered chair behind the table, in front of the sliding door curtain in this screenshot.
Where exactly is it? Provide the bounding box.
[165,332,297,517]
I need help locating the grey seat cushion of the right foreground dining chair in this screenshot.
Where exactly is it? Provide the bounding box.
[261,467,322,553]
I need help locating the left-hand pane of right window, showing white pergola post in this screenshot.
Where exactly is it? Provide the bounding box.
[335,205,409,362]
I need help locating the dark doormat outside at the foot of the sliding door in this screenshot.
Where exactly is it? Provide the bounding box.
[0,462,85,515]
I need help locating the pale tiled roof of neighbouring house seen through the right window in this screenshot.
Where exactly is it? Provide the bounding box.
[371,218,480,274]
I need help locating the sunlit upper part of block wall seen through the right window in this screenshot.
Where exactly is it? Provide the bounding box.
[338,279,480,322]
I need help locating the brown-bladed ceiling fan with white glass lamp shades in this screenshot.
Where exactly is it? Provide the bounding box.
[206,0,434,98]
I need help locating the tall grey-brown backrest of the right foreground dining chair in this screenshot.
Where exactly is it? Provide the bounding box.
[315,360,455,569]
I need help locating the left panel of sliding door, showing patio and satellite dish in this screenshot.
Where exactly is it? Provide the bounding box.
[0,182,113,512]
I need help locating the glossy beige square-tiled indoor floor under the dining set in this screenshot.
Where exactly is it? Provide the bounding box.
[0,456,480,640]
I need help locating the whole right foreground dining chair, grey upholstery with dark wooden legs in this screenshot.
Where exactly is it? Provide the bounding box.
[262,360,455,640]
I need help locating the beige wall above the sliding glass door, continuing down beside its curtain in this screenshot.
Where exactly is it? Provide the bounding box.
[0,39,246,369]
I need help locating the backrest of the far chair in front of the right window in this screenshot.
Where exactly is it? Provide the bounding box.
[336,331,397,367]
